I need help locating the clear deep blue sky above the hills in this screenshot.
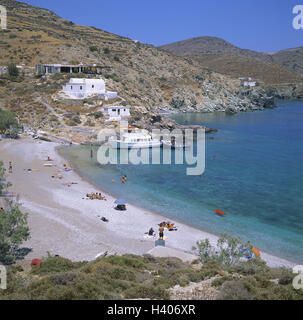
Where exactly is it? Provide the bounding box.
[19,0,303,52]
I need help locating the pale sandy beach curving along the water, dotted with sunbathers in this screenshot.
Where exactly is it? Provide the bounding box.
[0,138,295,267]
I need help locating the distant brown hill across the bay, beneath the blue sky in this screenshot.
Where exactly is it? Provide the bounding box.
[161,37,303,85]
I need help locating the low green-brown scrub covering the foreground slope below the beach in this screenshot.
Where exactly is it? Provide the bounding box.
[0,254,303,300]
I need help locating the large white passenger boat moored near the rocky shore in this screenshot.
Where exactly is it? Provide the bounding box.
[108,132,162,149]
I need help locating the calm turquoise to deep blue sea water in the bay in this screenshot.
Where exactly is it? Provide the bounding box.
[60,101,303,264]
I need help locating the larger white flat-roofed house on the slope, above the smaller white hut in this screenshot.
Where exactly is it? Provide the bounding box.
[63,78,106,98]
